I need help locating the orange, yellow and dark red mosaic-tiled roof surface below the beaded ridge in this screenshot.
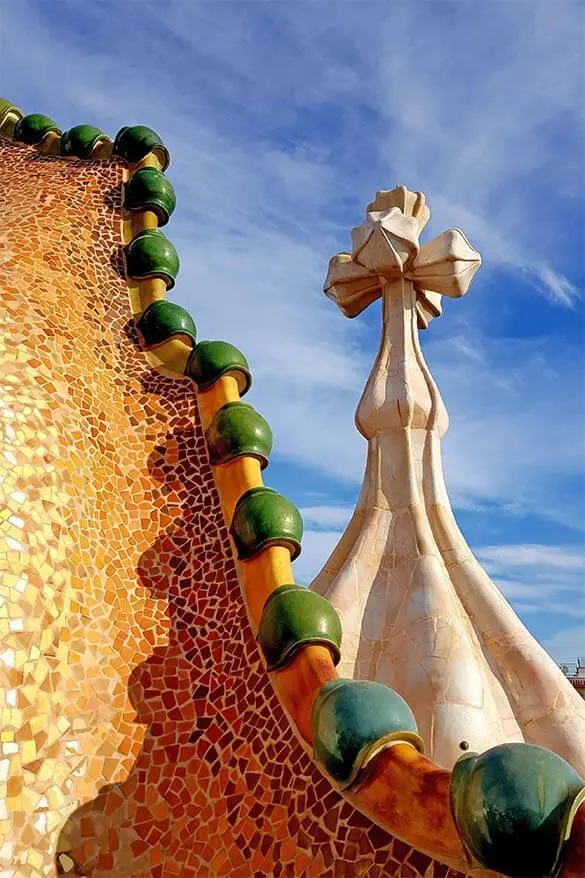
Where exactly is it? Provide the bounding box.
[0,143,466,878]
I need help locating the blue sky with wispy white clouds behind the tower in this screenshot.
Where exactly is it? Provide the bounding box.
[0,0,585,661]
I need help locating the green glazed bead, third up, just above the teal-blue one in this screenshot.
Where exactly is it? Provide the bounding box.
[258,585,341,671]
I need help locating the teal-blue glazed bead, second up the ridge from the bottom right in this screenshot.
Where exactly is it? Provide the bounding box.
[311,679,423,790]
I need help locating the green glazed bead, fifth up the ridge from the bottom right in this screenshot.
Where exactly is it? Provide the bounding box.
[205,402,272,469]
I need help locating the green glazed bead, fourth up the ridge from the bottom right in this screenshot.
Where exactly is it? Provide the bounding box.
[230,486,303,561]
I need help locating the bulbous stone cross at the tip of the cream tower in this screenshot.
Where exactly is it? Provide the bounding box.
[324,186,481,329]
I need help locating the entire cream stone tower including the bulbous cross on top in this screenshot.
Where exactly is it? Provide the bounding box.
[311,186,585,774]
